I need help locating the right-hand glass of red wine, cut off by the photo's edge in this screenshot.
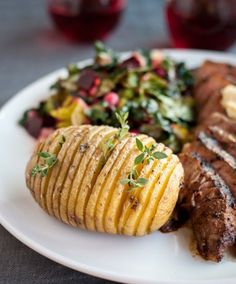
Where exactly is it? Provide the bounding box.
[166,0,236,50]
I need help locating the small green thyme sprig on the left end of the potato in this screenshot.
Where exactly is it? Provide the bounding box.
[31,152,57,177]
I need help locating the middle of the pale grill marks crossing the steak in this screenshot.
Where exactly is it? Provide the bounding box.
[198,131,236,170]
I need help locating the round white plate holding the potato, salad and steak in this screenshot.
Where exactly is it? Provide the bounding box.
[0,50,236,284]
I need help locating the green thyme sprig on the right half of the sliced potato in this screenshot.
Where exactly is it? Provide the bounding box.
[120,138,167,190]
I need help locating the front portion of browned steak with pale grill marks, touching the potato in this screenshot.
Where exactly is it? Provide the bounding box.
[162,113,236,262]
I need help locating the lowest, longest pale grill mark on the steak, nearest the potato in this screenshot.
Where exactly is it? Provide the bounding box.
[191,152,235,207]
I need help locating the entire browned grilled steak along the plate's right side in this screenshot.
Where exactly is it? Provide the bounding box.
[162,61,236,262]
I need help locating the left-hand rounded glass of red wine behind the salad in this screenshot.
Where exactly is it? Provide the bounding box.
[48,0,126,42]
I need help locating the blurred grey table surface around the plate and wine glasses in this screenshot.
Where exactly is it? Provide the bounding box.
[0,0,236,284]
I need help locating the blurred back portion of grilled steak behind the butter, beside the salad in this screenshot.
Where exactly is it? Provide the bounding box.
[194,61,236,123]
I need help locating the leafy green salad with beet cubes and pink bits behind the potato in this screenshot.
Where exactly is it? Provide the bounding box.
[19,42,194,152]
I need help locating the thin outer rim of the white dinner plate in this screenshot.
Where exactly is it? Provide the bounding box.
[0,49,236,284]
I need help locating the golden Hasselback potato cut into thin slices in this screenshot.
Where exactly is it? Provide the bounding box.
[26,125,184,236]
